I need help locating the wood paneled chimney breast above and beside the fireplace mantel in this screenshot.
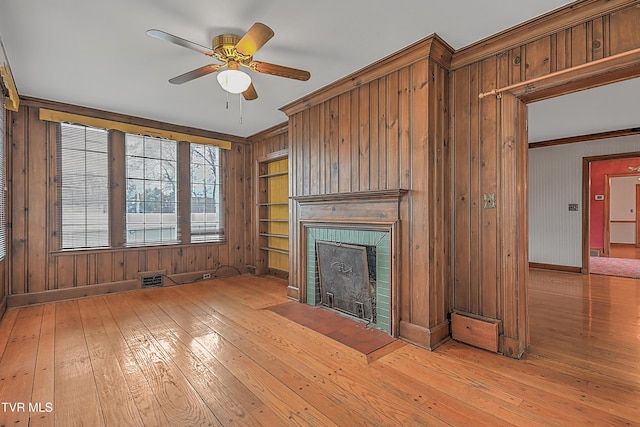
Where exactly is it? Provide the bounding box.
[283,36,452,348]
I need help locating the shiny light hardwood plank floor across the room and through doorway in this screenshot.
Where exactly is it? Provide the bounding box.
[0,270,640,427]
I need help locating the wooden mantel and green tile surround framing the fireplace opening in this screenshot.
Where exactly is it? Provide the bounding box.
[287,189,410,337]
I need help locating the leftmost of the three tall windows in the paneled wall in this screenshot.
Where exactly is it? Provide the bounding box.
[58,123,109,249]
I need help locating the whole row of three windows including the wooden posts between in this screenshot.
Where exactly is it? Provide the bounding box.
[53,117,224,251]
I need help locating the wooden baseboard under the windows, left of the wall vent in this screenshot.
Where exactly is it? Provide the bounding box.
[7,280,141,307]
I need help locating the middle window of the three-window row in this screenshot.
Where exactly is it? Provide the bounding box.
[125,134,178,245]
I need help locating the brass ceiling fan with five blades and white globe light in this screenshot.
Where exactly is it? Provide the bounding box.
[147,22,311,101]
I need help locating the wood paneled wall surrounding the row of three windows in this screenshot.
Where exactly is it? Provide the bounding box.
[8,100,254,304]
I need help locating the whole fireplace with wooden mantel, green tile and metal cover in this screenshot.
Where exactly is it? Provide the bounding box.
[287,189,407,337]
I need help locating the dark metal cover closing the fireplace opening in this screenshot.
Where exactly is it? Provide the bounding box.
[316,241,375,321]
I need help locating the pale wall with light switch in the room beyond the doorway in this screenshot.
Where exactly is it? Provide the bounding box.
[529,135,640,267]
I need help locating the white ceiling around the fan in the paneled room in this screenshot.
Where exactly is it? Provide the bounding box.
[0,0,638,140]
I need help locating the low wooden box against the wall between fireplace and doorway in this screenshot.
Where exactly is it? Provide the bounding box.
[451,313,500,353]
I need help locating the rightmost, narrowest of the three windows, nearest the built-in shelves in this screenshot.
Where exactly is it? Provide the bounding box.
[190,143,223,242]
